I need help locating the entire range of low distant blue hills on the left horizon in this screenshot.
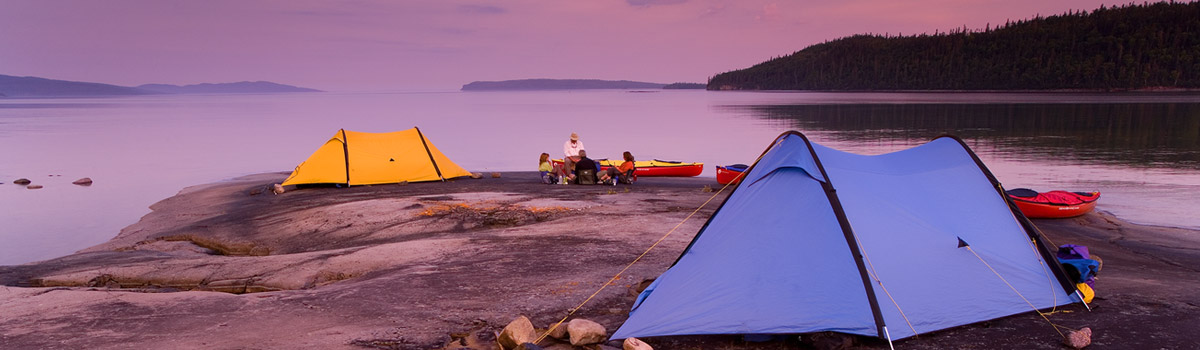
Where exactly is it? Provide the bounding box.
[0,74,320,98]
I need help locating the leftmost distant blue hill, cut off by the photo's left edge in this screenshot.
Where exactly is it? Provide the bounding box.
[0,76,148,97]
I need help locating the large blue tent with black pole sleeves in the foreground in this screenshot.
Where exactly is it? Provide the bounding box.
[612,132,1080,340]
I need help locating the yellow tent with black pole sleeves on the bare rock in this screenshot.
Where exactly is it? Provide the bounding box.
[283,127,470,186]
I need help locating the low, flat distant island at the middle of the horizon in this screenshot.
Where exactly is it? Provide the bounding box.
[462,79,706,91]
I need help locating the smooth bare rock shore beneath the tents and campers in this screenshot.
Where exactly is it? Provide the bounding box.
[0,173,1200,349]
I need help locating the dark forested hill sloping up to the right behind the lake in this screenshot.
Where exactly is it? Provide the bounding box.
[708,2,1200,90]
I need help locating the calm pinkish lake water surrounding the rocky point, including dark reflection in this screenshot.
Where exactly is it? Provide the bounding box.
[0,91,1200,265]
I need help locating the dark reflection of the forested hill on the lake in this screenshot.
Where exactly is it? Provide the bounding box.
[725,103,1200,169]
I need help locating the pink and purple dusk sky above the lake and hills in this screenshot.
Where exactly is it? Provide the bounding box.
[0,0,1113,91]
